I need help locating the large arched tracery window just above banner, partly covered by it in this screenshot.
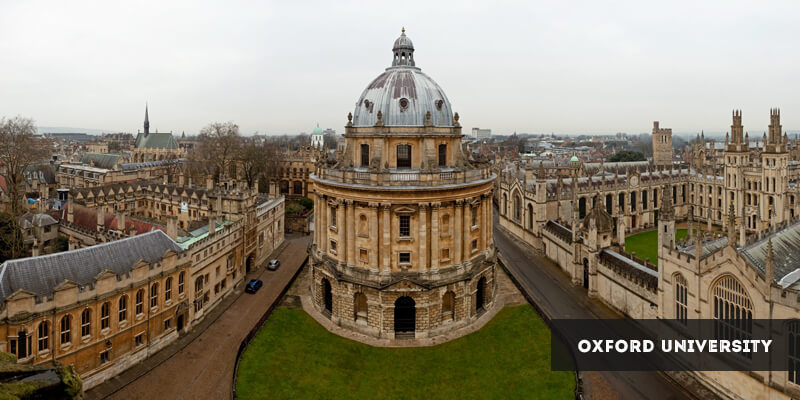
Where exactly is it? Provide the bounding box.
[711,275,753,340]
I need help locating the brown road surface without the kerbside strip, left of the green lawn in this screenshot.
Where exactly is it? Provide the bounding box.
[97,236,311,399]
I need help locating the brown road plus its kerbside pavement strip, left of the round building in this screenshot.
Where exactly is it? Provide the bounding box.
[85,234,311,400]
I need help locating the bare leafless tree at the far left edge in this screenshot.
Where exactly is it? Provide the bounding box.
[0,116,50,216]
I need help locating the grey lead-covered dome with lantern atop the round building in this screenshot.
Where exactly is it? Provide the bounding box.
[353,29,453,127]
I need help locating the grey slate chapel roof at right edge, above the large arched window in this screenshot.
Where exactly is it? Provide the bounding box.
[742,222,800,282]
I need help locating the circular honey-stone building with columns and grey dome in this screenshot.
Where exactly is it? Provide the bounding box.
[310,31,496,338]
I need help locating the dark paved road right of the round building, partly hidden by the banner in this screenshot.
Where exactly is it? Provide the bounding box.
[494,213,687,399]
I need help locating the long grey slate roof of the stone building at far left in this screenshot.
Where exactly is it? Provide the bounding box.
[0,231,183,301]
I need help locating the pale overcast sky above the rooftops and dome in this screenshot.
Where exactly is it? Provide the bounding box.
[0,0,800,134]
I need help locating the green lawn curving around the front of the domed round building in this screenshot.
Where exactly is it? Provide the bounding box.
[236,305,575,399]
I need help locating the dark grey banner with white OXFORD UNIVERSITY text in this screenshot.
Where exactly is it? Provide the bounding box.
[550,317,800,373]
